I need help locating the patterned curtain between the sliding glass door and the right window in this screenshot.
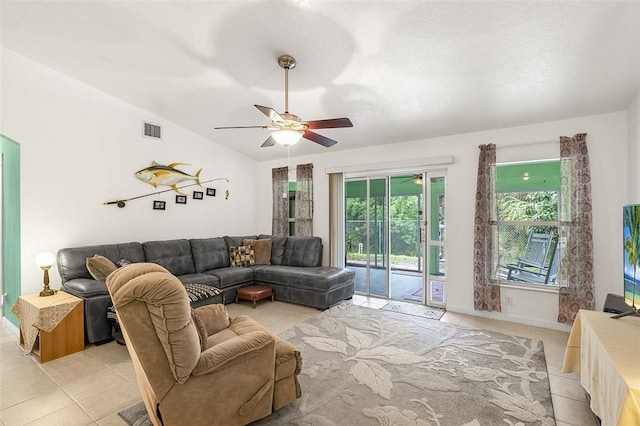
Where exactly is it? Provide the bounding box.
[473,144,502,312]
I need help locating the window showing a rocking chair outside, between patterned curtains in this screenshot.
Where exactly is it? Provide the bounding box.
[496,160,560,286]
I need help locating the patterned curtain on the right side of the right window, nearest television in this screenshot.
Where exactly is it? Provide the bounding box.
[558,133,595,324]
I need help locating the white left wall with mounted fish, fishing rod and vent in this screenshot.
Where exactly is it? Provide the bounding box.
[0,48,260,294]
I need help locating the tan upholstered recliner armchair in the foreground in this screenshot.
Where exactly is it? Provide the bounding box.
[107,263,302,425]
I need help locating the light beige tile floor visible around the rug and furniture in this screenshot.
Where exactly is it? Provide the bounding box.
[0,296,597,426]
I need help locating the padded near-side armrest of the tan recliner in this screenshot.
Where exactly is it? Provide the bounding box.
[192,331,275,376]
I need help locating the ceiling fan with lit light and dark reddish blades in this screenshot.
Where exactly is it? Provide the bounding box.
[215,55,353,147]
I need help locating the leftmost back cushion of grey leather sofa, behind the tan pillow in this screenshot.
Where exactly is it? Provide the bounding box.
[56,242,145,283]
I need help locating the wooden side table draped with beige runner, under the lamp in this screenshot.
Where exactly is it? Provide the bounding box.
[11,291,84,362]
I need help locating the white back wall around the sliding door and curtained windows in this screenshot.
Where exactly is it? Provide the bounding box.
[258,112,627,329]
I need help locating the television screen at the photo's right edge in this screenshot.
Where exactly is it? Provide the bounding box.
[622,205,640,309]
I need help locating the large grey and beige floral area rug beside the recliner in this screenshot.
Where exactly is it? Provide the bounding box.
[121,303,555,426]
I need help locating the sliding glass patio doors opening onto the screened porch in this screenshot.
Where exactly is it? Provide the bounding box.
[344,172,446,306]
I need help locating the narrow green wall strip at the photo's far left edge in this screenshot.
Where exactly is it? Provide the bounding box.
[0,134,22,327]
